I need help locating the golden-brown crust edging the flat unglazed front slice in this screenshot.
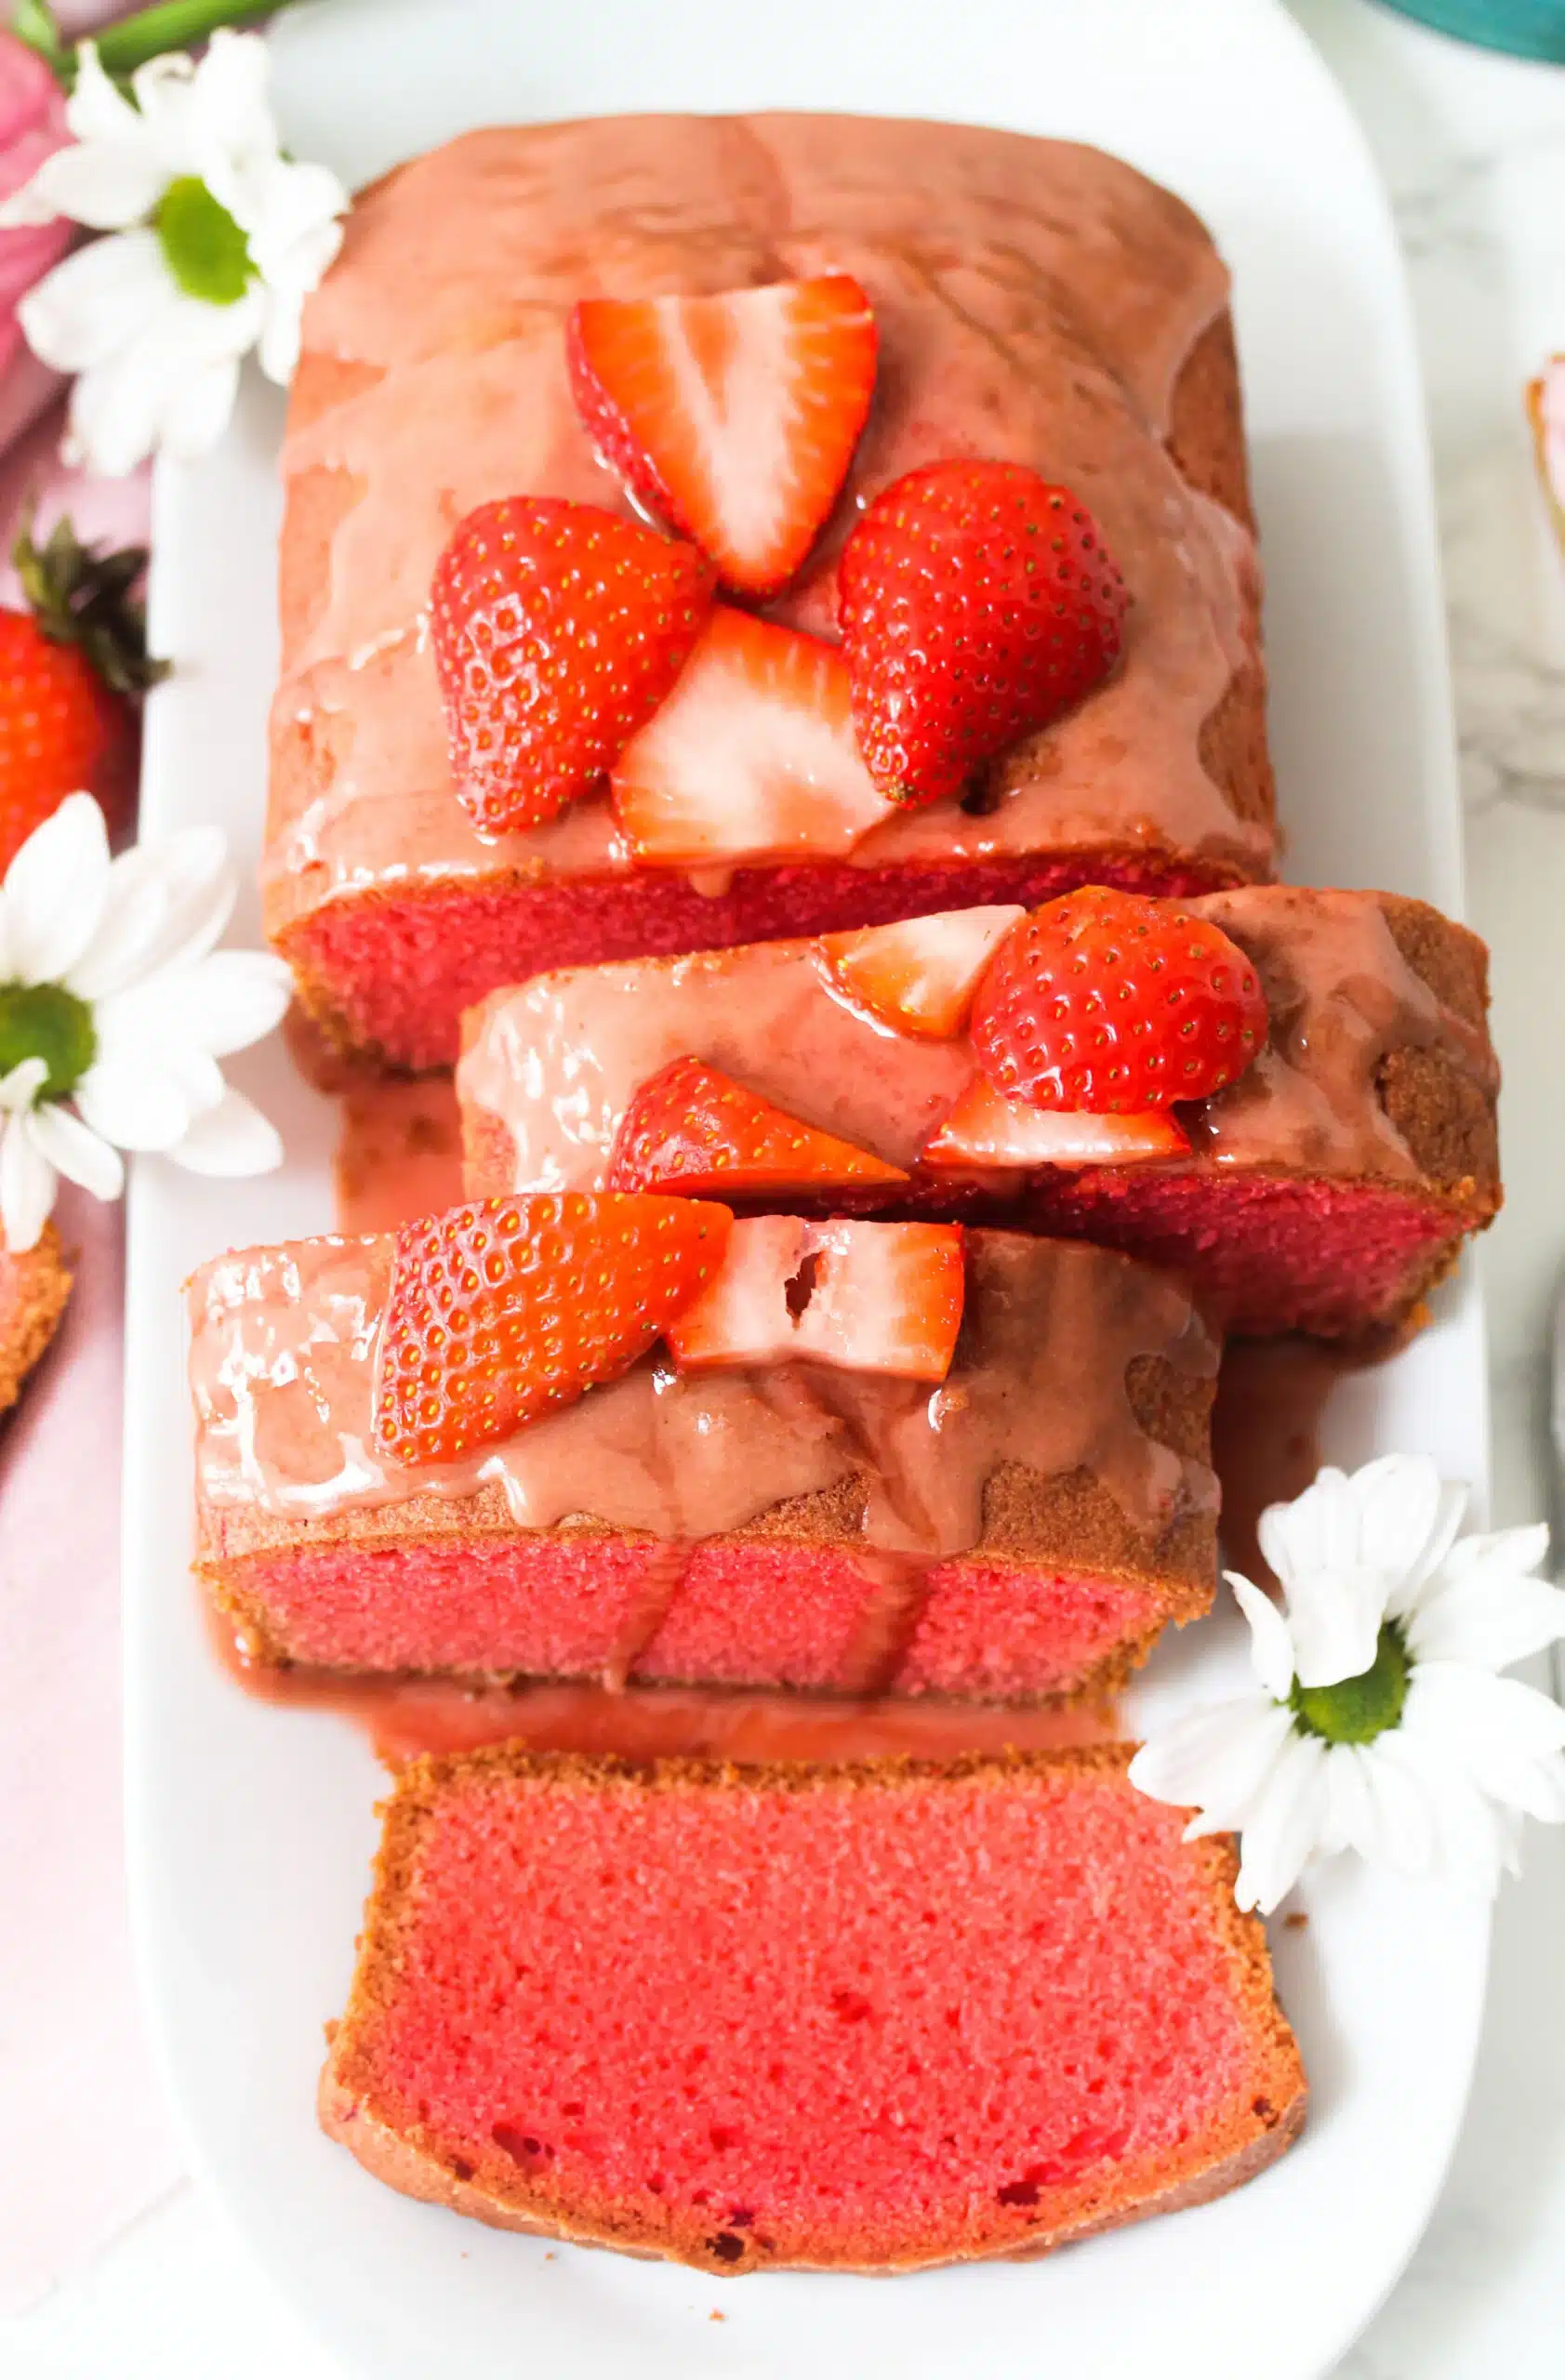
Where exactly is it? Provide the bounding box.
[317,1744,1307,2280]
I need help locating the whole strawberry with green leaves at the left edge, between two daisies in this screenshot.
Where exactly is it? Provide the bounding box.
[0,522,166,876]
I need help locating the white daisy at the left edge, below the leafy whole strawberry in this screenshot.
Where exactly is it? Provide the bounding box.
[0,792,288,1250]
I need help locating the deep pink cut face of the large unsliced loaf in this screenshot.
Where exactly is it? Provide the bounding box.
[285,852,1213,1068]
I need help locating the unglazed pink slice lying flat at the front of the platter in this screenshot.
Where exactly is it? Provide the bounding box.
[319,1744,1306,2273]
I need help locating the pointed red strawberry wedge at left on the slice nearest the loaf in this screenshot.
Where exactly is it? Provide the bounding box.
[607,1057,908,1197]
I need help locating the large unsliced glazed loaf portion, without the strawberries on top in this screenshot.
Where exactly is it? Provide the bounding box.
[264,114,1274,1066]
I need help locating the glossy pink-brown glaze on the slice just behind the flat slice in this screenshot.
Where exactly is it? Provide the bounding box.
[188,1233,1217,1559]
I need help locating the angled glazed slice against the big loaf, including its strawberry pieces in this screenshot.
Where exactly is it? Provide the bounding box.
[458,885,1501,1340]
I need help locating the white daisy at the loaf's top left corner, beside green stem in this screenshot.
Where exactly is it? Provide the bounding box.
[0,31,348,476]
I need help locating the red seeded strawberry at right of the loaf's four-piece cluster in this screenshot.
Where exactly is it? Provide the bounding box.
[836,459,1127,804]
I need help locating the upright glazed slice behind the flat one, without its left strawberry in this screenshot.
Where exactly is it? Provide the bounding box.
[188,1209,1217,1699]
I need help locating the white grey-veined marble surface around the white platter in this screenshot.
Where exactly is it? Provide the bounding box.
[0,0,1565,2380]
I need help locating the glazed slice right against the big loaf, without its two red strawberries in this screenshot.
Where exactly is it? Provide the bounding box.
[458,885,1501,1340]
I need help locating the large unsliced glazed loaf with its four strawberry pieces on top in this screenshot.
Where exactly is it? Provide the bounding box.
[264,114,1274,1068]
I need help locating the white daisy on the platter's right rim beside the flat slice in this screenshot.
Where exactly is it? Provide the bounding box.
[1129,1454,1565,1911]
